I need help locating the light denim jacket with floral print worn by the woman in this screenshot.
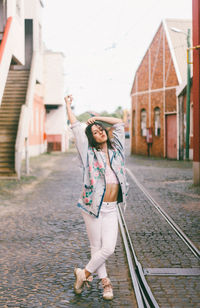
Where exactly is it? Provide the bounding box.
[71,121,128,218]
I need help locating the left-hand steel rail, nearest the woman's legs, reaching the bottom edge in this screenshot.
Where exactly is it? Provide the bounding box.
[117,205,159,308]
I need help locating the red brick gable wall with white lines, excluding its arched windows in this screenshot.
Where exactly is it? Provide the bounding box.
[131,24,178,157]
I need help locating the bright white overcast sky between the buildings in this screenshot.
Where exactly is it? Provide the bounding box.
[43,0,192,114]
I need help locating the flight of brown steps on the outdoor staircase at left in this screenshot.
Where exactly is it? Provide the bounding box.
[0,70,30,177]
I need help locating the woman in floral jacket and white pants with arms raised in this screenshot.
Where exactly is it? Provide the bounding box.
[65,95,126,300]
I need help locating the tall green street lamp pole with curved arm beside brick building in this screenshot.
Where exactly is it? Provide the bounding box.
[170,27,191,160]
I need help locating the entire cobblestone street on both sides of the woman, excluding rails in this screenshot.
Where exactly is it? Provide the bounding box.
[0,147,200,308]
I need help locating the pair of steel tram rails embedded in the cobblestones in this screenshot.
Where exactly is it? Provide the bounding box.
[118,169,200,308]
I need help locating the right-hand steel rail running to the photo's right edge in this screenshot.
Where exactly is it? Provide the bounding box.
[126,168,200,259]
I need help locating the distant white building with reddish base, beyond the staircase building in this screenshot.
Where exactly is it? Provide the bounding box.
[44,50,69,152]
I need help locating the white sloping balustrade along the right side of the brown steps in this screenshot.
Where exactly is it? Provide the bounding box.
[15,51,38,179]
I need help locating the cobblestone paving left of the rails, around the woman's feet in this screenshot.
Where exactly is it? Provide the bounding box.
[0,154,135,307]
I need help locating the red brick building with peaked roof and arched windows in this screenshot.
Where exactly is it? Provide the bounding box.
[131,19,191,159]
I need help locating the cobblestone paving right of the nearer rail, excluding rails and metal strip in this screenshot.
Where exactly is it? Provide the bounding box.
[125,146,200,307]
